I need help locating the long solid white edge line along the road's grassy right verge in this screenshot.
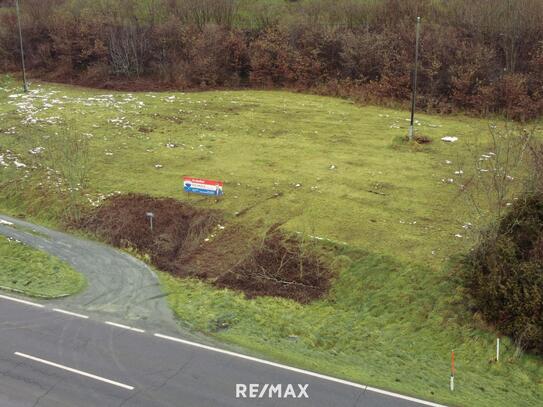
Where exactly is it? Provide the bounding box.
[154,333,446,407]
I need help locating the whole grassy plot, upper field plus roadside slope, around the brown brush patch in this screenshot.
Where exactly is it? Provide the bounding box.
[0,80,543,406]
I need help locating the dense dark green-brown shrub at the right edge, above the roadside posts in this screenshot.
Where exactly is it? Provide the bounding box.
[462,194,543,353]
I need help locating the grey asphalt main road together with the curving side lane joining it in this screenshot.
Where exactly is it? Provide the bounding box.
[0,216,446,407]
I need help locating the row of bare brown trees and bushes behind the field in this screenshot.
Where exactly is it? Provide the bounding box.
[0,0,543,120]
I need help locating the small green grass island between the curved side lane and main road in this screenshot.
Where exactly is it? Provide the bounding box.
[0,236,85,298]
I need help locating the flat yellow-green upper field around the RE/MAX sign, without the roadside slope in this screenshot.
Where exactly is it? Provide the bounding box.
[0,78,510,264]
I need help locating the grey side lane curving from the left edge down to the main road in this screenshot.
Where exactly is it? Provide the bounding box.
[0,214,177,331]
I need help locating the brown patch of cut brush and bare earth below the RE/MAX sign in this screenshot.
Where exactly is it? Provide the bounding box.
[77,194,333,303]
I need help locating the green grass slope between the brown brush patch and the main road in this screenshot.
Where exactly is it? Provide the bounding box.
[159,252,543,406]
